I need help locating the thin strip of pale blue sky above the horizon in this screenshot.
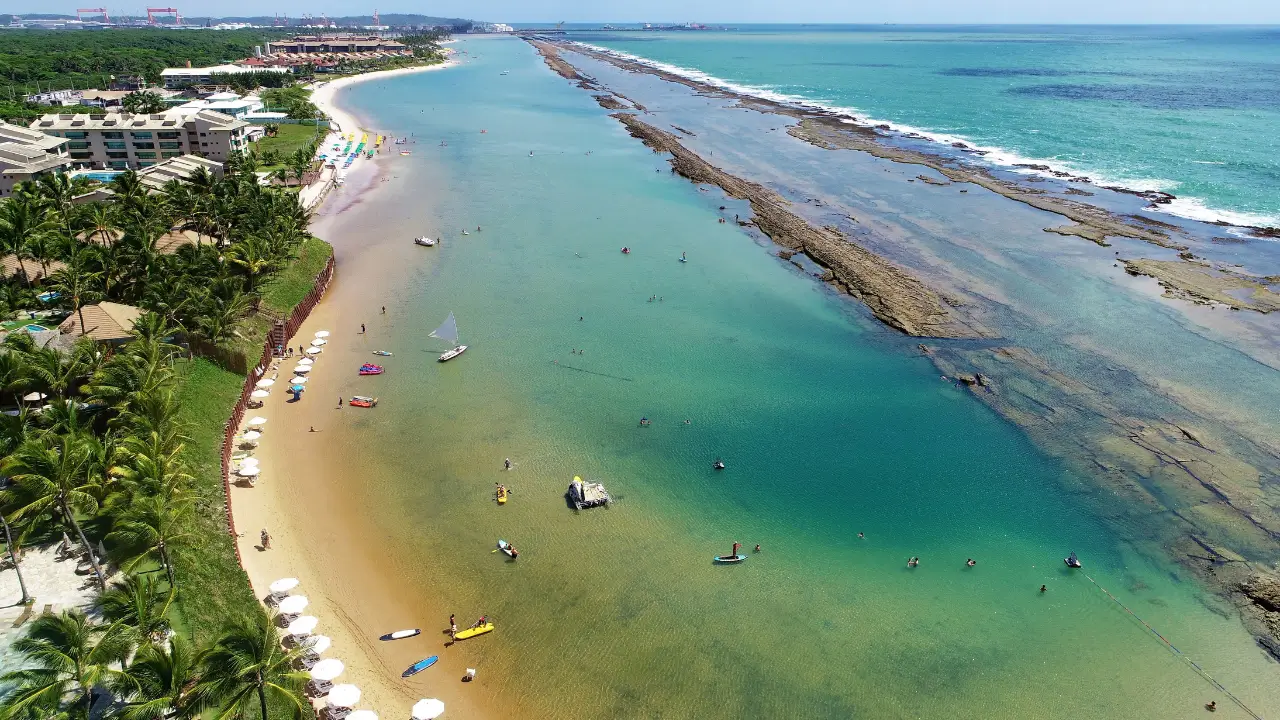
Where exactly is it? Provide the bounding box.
[15,0,1280,24]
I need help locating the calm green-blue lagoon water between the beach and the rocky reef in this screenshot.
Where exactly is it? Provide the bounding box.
[325,38,1280,719]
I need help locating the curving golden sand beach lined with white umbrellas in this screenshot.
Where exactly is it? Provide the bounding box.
[230,54,496,717]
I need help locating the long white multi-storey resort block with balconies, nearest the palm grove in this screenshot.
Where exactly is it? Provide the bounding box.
[31,110,248,170]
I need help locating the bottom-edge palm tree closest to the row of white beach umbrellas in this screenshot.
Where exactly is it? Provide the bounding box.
[192,610,310,720]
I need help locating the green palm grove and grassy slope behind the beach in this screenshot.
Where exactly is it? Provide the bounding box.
[0,156,323,720]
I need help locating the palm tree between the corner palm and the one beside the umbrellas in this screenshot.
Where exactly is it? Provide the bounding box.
[119,635,196,720]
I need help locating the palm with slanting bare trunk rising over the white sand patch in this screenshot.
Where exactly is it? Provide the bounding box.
[0,436,106,588]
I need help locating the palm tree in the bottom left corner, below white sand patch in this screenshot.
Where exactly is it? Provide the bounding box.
[0,610,129,720]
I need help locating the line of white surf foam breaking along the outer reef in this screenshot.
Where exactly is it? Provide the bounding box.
[577,41,1280,227]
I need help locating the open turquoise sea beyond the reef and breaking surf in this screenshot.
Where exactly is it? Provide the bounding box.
[570,26,1280,225]
